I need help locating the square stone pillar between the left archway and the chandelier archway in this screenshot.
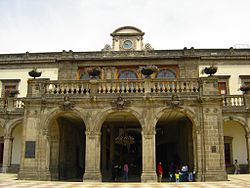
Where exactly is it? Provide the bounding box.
[83,131,102,182]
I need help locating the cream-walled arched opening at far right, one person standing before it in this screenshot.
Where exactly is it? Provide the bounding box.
[223,120,248,173]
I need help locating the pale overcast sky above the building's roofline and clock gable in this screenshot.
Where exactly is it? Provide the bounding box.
[0,0,250,54]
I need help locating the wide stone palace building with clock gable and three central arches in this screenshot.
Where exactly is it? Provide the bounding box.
[0,26,250,182]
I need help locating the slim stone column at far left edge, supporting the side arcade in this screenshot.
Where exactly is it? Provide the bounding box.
[2,135,13,173]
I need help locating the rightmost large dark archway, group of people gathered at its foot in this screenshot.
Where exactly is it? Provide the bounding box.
[156,110,194,181]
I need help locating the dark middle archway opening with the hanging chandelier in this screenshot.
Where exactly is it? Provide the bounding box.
[101,112,142,182]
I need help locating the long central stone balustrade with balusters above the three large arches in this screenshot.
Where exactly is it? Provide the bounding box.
[45,79,199,95]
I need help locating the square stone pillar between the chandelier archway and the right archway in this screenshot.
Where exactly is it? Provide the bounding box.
[141,130,157,182]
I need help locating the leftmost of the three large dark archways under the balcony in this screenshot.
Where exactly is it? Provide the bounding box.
[50,113,86,181]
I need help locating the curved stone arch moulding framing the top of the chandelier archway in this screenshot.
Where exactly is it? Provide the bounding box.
[94,108,144,131]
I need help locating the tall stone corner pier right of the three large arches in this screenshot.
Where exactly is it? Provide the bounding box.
[198,76,227,181]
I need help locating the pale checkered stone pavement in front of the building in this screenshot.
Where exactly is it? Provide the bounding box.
[0,173,250,188]
